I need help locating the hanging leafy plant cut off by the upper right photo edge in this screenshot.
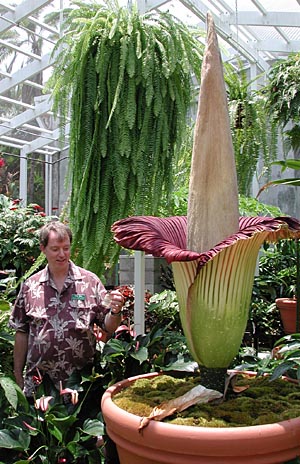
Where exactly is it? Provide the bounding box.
[265,53,300,149]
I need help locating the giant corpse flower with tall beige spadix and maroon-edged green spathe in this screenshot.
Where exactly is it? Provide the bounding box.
[112,14,300,390]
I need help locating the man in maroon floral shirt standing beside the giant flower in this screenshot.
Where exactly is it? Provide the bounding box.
[10,221,123,397]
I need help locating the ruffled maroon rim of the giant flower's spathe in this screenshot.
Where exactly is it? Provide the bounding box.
[112,216,300,267]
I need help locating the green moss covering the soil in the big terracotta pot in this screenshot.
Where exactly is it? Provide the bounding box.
[114,375,300,427]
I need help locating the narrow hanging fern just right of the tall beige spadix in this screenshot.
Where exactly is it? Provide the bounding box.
[224,64,277,195]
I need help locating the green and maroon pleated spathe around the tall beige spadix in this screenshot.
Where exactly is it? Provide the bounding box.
[112,216,300,368]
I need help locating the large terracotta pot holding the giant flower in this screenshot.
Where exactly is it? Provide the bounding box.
[102,373,300,464]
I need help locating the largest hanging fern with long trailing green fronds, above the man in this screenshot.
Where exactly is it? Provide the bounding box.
[50,0,203,275]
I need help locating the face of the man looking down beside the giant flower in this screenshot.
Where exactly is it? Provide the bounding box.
[41,230,70,272]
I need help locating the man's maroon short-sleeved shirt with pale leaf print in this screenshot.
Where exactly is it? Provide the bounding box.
[9,261,108,396]
